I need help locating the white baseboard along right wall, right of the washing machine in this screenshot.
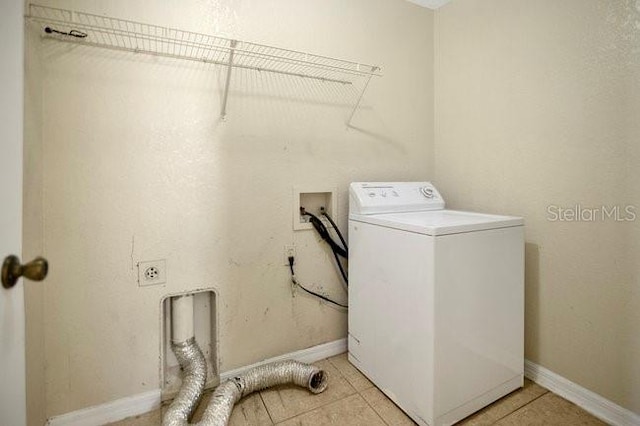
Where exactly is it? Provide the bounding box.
[524,360,640,426]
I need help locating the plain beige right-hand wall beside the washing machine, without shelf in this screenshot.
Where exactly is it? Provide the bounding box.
[435,0,640,413]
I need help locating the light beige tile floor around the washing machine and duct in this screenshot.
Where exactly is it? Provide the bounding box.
[112,354,605,426]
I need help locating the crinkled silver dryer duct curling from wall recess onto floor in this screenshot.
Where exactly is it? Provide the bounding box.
[162,296,328,426]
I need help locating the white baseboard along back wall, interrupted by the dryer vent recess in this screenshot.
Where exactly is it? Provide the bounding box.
[47,339,347,426]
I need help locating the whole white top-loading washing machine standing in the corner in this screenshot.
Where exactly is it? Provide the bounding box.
[349,182,524,426]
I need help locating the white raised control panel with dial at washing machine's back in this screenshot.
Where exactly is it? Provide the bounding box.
[349,182,444,214]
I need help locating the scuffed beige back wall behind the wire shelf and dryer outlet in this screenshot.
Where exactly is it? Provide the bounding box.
[26,0,433,423]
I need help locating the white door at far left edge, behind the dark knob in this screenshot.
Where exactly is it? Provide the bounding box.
[0,0,27,426]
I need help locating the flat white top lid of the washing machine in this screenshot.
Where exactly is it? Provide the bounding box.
[349,210,524,236]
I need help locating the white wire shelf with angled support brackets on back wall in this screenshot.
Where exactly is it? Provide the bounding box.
[27,4,381,121]
